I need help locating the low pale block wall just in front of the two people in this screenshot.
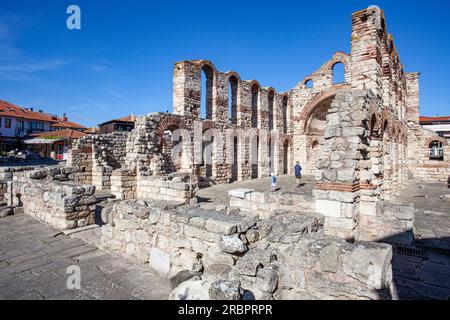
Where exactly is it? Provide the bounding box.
[228,189,315,219]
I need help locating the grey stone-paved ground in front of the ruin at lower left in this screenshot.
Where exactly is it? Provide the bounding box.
[0,214,170,300]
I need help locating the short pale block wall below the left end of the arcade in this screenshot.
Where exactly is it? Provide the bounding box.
[136,174,195,204]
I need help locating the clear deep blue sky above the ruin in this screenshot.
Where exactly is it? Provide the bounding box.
[0,0,450,126]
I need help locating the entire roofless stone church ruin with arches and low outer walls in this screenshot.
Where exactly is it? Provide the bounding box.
[1,6,450,299]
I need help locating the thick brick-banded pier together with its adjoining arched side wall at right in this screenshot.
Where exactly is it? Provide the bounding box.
[314,90,413,240]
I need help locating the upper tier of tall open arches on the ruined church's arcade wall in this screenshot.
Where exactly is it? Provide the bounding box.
[173,60,291,133]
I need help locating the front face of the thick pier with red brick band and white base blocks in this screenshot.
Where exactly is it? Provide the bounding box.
[314,90,374,239]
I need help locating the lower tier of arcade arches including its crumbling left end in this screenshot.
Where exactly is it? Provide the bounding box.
[126,113,293,186]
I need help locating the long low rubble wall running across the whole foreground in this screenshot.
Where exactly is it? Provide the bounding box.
[101,200,392,299]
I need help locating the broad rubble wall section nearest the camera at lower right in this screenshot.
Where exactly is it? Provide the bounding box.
[236,234,395,300]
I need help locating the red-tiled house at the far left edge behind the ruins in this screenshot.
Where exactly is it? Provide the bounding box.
[0,100,86,151]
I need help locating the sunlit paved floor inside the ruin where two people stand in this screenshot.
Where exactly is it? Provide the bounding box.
[196,175,315,206]
